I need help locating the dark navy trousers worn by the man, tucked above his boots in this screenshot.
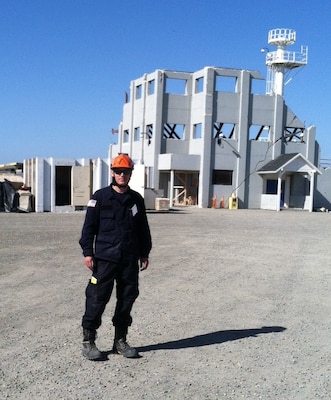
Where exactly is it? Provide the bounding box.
[82,260,139,330]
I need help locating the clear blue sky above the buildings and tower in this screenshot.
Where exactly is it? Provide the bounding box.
[0,0,331,164]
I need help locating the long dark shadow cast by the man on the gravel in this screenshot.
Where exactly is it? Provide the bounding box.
[137,326,286,353]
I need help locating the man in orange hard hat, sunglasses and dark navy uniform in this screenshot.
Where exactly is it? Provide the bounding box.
[79,154,152,360]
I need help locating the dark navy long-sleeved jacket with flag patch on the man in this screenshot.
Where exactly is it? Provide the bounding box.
[79,186,152,262]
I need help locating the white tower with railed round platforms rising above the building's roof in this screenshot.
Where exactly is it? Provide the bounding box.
[261,28,308,96]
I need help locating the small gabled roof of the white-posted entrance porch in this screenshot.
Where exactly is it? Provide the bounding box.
[257,153,321,175]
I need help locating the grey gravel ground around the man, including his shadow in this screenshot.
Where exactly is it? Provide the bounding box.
[0,207,331,400]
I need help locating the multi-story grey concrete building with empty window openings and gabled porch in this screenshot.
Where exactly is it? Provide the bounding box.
[110,67,320,211]
